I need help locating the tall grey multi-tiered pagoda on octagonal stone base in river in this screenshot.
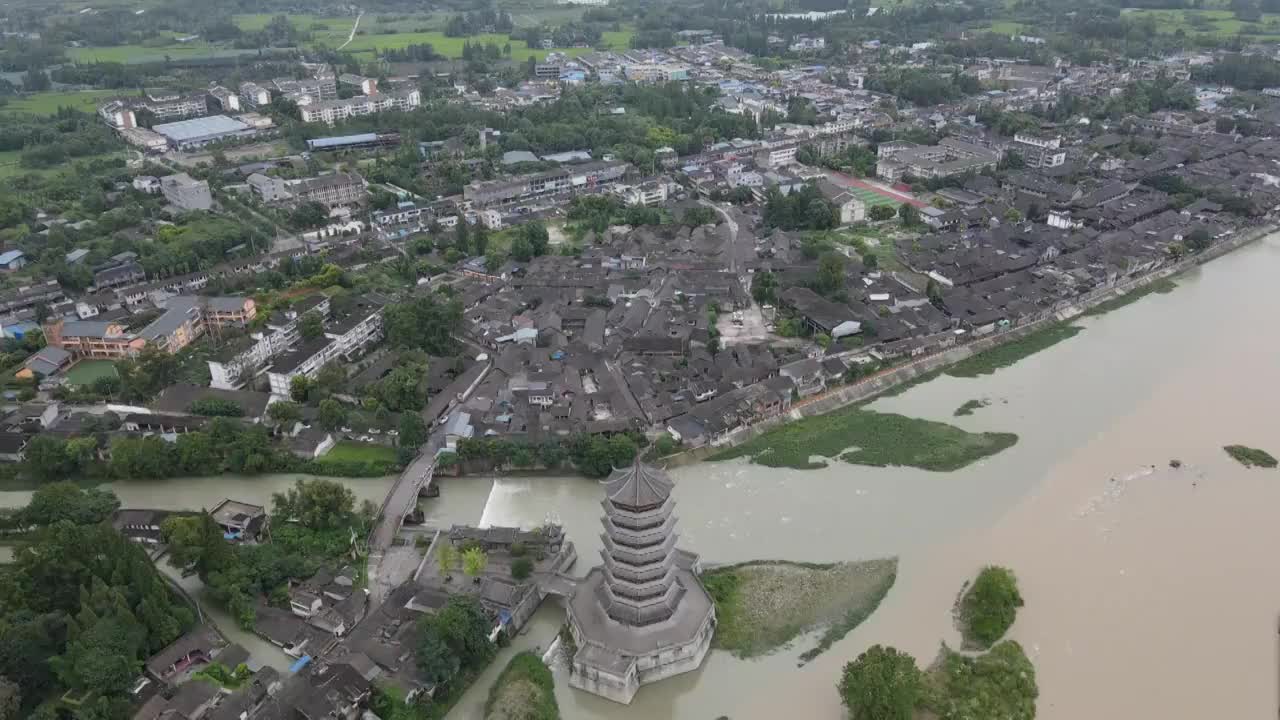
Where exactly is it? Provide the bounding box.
[568,460,716,703]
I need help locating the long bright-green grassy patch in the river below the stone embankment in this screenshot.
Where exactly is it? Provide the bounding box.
[710,405,1018,471]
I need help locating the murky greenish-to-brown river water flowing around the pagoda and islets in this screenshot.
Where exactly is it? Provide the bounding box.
[0,236,1280,720]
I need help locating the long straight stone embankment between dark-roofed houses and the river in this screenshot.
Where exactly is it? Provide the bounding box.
[666,224,1280,468]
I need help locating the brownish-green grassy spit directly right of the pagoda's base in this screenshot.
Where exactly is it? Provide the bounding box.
[703,559,897,662]
